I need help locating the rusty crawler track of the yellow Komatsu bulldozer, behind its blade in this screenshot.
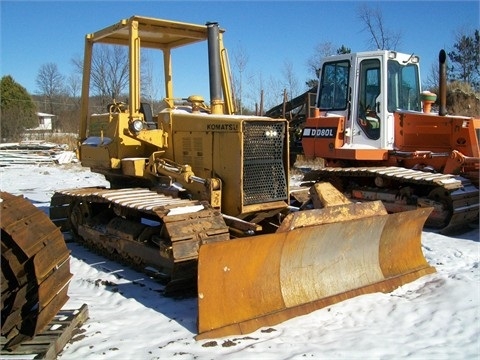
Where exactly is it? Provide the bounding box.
[50,188,229,295]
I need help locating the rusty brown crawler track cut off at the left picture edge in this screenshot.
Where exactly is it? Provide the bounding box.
[0,192,72,350]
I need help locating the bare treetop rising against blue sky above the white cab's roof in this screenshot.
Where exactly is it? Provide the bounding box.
[357,3,401,50]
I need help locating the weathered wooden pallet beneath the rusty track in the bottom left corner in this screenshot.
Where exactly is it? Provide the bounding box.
[0,304,88,360]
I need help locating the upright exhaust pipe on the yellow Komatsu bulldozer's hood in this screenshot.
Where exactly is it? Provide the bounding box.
[206,22,223,114]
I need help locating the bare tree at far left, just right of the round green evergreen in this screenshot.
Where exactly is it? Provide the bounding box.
[35,63,65,114]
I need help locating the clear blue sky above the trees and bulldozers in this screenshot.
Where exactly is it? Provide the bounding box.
[0,0,480,108]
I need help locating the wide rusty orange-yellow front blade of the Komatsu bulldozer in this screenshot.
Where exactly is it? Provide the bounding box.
[196,208,436,340]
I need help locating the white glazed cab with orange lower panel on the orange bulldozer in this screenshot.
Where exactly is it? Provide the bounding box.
[302,51,421,160]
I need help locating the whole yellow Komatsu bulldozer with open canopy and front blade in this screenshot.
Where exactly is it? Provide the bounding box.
[50,16,435,339]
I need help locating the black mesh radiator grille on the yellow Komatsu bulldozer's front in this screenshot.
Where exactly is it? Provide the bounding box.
[243,122,288,205]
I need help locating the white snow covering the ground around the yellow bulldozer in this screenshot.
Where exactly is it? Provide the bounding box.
[0,164,480,360]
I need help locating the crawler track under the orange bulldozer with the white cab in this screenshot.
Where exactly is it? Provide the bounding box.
[303,166,479,233]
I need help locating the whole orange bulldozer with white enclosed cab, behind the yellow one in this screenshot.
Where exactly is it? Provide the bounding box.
[297,50,480,233]
